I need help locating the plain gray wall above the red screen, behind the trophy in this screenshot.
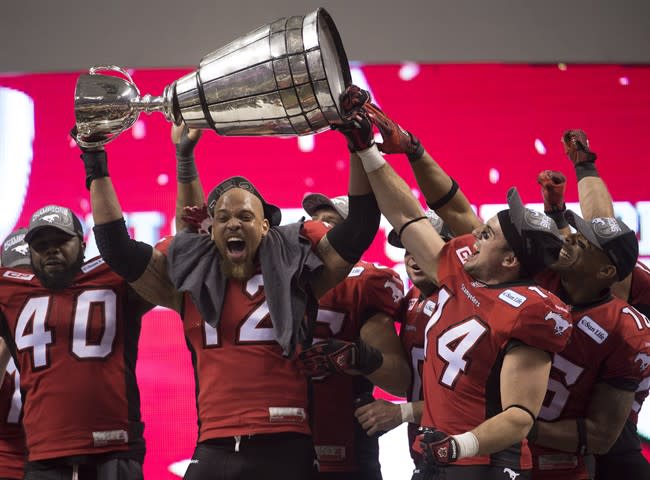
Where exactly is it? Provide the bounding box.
[0,0,650,72]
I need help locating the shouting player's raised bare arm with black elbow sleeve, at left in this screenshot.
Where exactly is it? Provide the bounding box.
[81,149,182,312]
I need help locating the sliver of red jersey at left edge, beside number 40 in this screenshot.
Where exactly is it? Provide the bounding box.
[0,359,26,478]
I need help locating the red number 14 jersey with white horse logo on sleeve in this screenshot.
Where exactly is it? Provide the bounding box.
[422,235,571,469]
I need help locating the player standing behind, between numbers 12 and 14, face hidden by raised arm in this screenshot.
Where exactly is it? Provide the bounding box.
[302,193,409,480]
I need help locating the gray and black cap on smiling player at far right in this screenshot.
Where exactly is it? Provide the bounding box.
[564,210,639,280]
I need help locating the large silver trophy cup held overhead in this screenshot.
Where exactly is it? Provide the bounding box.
[74,8,351,147]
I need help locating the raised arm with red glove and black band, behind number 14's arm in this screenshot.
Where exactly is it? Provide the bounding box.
[364,103,483,235]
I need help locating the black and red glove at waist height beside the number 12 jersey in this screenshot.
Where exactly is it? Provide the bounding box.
[298,338,384,377]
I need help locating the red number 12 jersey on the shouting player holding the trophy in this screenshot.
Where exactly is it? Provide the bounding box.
[167,221,327,442]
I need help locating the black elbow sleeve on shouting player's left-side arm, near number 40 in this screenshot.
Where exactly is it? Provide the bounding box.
[93,218,153,282]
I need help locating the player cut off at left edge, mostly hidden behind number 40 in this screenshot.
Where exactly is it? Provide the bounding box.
[0,228,31,479]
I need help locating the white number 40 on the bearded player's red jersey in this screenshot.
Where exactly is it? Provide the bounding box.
[15,289,117,370]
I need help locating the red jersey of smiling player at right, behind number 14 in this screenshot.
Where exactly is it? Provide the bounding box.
[531,288,650,479]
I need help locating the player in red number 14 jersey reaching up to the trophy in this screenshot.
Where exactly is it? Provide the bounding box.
[332,90,571,479]
